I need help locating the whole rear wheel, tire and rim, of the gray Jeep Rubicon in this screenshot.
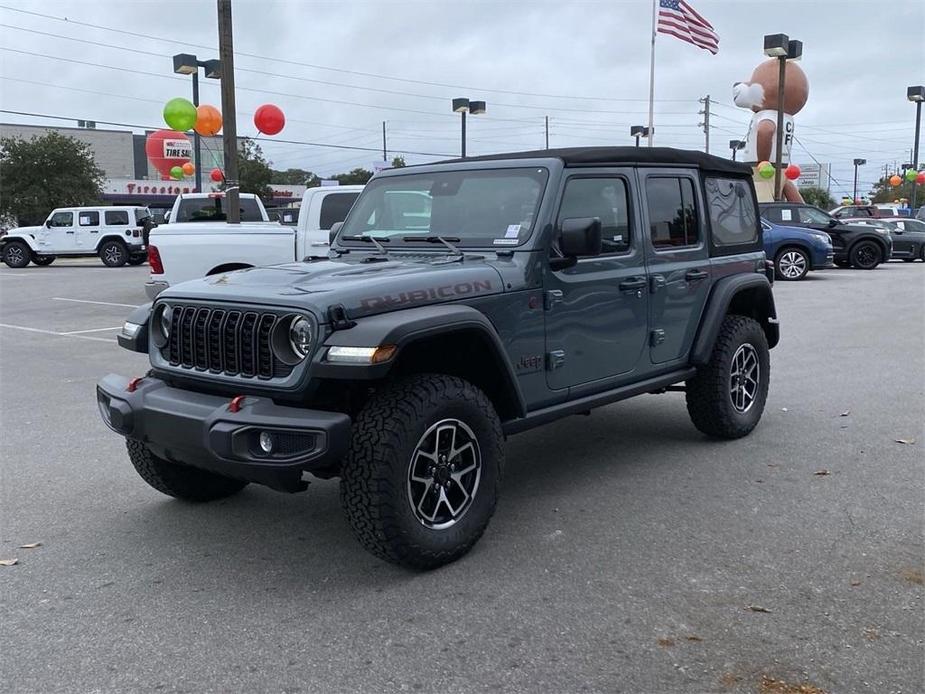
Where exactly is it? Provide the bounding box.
[686,315,770,439]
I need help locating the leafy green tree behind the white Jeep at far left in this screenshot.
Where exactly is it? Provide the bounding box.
[0,131,106,225]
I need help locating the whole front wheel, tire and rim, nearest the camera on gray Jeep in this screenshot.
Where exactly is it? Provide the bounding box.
[340,374,504,569]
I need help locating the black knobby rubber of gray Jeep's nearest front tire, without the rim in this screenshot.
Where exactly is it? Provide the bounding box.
[340,374,504,569]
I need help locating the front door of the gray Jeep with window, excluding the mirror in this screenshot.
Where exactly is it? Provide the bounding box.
[544,169,648,390]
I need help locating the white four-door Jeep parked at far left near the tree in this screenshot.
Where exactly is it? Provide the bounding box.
[0,207,152,268]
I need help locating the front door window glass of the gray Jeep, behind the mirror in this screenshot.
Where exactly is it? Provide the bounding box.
[557,178,630,255]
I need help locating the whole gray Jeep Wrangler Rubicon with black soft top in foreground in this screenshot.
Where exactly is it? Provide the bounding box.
[97,147,778,569]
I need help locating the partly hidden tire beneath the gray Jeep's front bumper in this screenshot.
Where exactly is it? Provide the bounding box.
[125,439,247,501]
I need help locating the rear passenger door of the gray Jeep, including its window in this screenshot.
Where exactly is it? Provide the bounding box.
[642,169,710,364]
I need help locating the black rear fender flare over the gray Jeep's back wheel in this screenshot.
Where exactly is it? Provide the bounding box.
[690,273,780,366]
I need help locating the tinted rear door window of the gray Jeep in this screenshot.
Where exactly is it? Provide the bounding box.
[646,176,700,249]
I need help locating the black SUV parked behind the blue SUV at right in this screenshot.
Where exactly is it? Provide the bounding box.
[759,202,893,270]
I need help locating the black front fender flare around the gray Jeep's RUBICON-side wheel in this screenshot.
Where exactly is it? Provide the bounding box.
[312,304,526,417]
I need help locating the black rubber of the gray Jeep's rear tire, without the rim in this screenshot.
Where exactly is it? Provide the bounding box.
[686,314,770,439]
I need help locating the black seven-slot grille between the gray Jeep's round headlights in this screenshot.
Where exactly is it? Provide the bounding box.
[163,306,291,378]
